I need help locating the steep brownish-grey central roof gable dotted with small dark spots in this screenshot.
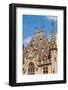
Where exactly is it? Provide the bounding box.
[29,28,49,60]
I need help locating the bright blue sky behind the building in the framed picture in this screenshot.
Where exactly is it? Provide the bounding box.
[22,15,57,46]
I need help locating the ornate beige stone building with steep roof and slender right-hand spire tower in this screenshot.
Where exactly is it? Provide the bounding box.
[22,19,57,75]
